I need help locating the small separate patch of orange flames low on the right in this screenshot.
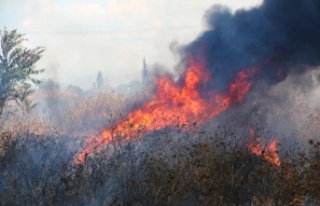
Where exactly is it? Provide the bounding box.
[248,128,281,166]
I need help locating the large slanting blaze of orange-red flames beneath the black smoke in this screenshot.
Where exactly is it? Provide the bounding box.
[75,61,258,164]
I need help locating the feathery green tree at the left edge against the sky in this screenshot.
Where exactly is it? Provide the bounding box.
[0,28,44,117]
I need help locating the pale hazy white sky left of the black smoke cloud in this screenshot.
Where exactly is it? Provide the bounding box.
[0,0,262,89]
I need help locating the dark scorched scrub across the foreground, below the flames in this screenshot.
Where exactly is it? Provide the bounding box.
[0,127,320,205]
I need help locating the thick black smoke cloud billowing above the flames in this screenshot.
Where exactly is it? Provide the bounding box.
[183,0,320,90]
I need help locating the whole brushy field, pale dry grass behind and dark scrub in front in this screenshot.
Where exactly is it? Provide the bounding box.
[0,87,320,205]
